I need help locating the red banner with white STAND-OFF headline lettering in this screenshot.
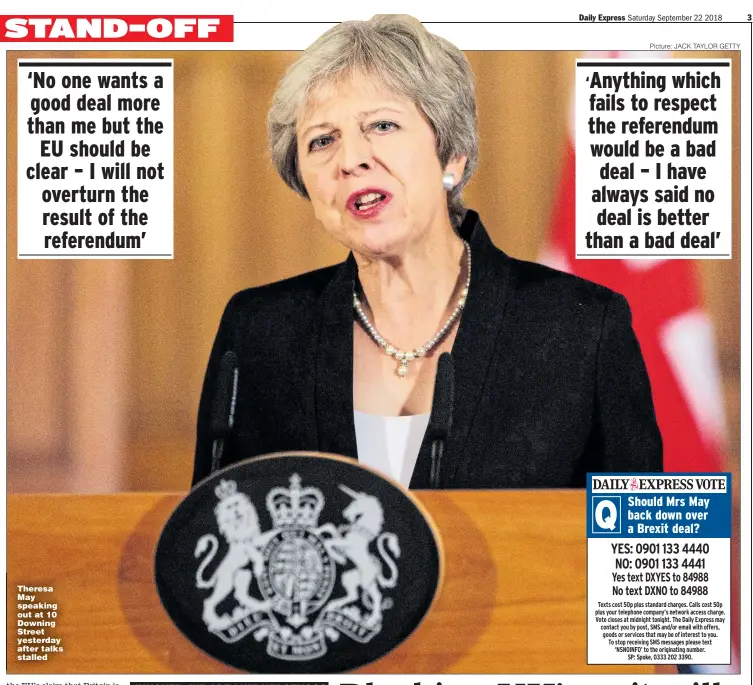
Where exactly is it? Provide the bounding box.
[0,14,233,43]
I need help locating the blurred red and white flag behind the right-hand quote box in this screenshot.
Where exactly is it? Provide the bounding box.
[540,52,740,673]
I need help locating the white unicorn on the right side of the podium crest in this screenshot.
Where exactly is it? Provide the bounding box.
[321,485,400,628]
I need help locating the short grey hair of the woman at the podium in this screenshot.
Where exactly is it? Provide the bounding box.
[268,14,478,226]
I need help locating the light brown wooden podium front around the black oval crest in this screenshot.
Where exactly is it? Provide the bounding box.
[6,490,654,674]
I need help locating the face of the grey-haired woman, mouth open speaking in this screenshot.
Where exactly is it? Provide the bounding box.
[297,73,465,257]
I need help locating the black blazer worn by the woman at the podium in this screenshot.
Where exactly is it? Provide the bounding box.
[193,211,662,488]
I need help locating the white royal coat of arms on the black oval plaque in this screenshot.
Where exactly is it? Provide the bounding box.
[195,473,400,661]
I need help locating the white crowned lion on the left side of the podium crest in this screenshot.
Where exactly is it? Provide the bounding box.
[194,480,269,630]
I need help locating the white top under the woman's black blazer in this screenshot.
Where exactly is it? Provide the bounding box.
[353,411,429,488]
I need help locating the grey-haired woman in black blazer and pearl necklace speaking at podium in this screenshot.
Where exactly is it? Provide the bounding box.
[193,16,662,488]
